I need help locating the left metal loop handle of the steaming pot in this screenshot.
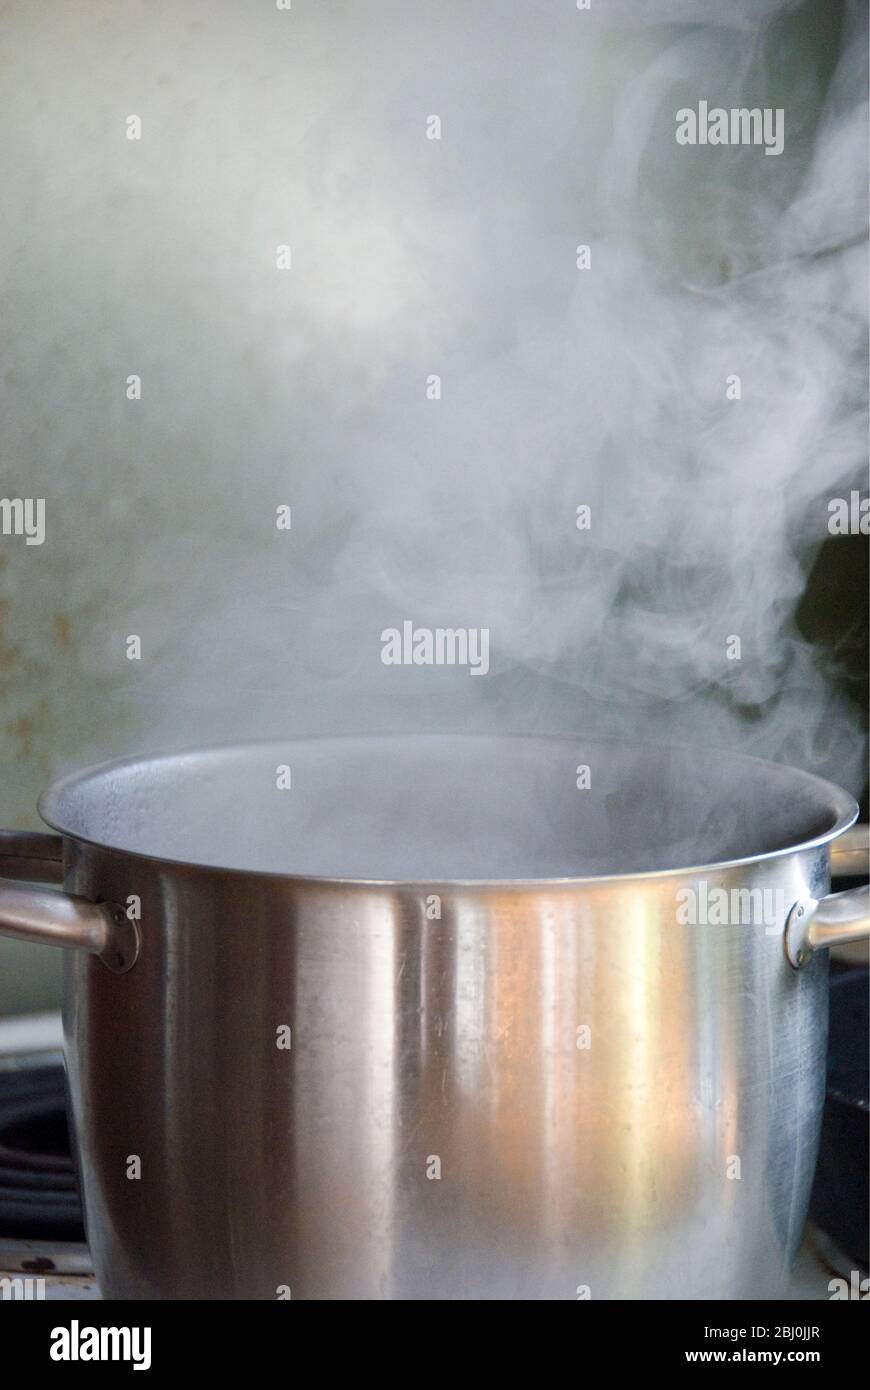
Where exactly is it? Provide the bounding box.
[0,830,139,974]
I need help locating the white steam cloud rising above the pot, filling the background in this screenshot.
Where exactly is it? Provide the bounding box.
[1,0,867,790]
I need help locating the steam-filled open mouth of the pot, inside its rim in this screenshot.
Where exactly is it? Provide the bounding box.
[43,737,851,880]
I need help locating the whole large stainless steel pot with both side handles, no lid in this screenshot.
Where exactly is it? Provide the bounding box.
[0,738,867,1300]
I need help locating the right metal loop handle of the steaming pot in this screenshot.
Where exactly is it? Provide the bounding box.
[785,826,870,970]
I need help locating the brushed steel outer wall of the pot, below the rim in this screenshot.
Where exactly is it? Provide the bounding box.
[64,838,828,1300]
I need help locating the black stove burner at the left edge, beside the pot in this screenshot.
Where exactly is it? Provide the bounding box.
[0,1066,85,1241]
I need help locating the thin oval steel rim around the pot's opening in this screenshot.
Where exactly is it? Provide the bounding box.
[36,733,860,891]
